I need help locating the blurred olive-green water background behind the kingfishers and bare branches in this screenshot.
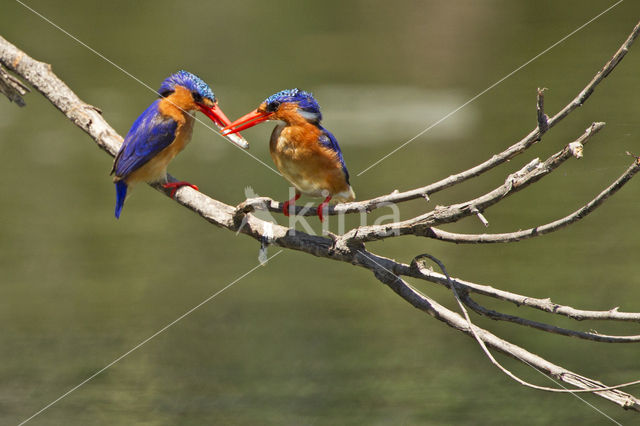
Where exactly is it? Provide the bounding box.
[0,0,640,425]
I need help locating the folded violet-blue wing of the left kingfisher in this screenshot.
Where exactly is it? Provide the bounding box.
[113,99,178,178]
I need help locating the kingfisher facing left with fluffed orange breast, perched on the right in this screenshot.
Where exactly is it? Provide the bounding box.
[222,89,356,221]
